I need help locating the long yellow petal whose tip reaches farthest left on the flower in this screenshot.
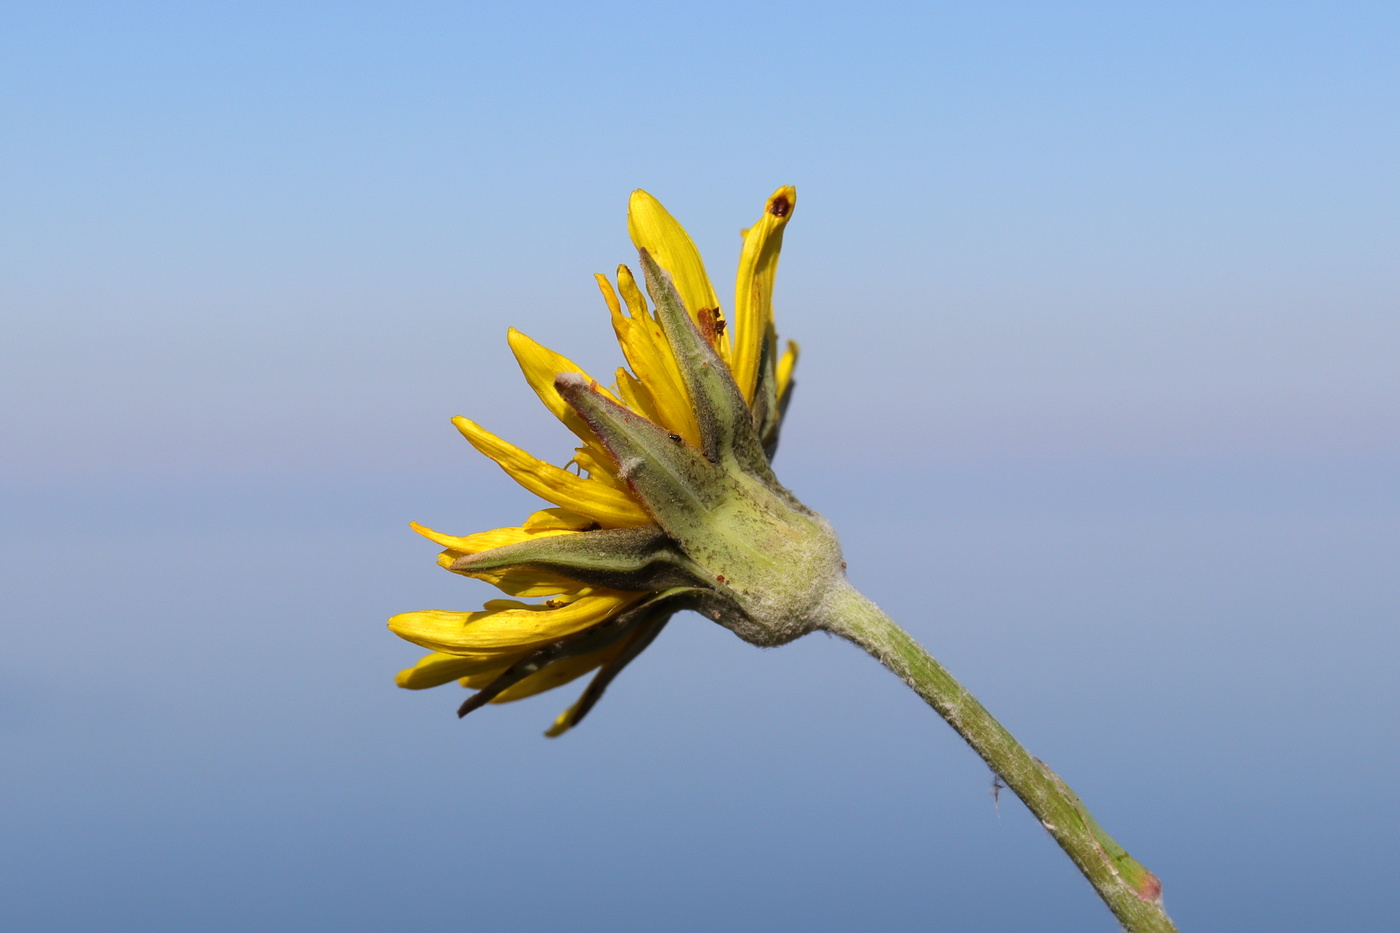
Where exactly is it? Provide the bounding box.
[389,590,644,654]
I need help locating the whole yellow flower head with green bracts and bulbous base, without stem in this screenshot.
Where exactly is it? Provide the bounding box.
[389,188,840,735]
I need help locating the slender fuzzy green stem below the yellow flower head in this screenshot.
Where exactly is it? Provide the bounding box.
[822,583,1176,933]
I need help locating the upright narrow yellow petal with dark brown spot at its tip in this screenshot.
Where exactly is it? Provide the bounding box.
[732,185,797,401]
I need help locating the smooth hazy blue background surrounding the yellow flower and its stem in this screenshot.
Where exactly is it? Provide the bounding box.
[0,3,1400,933]
